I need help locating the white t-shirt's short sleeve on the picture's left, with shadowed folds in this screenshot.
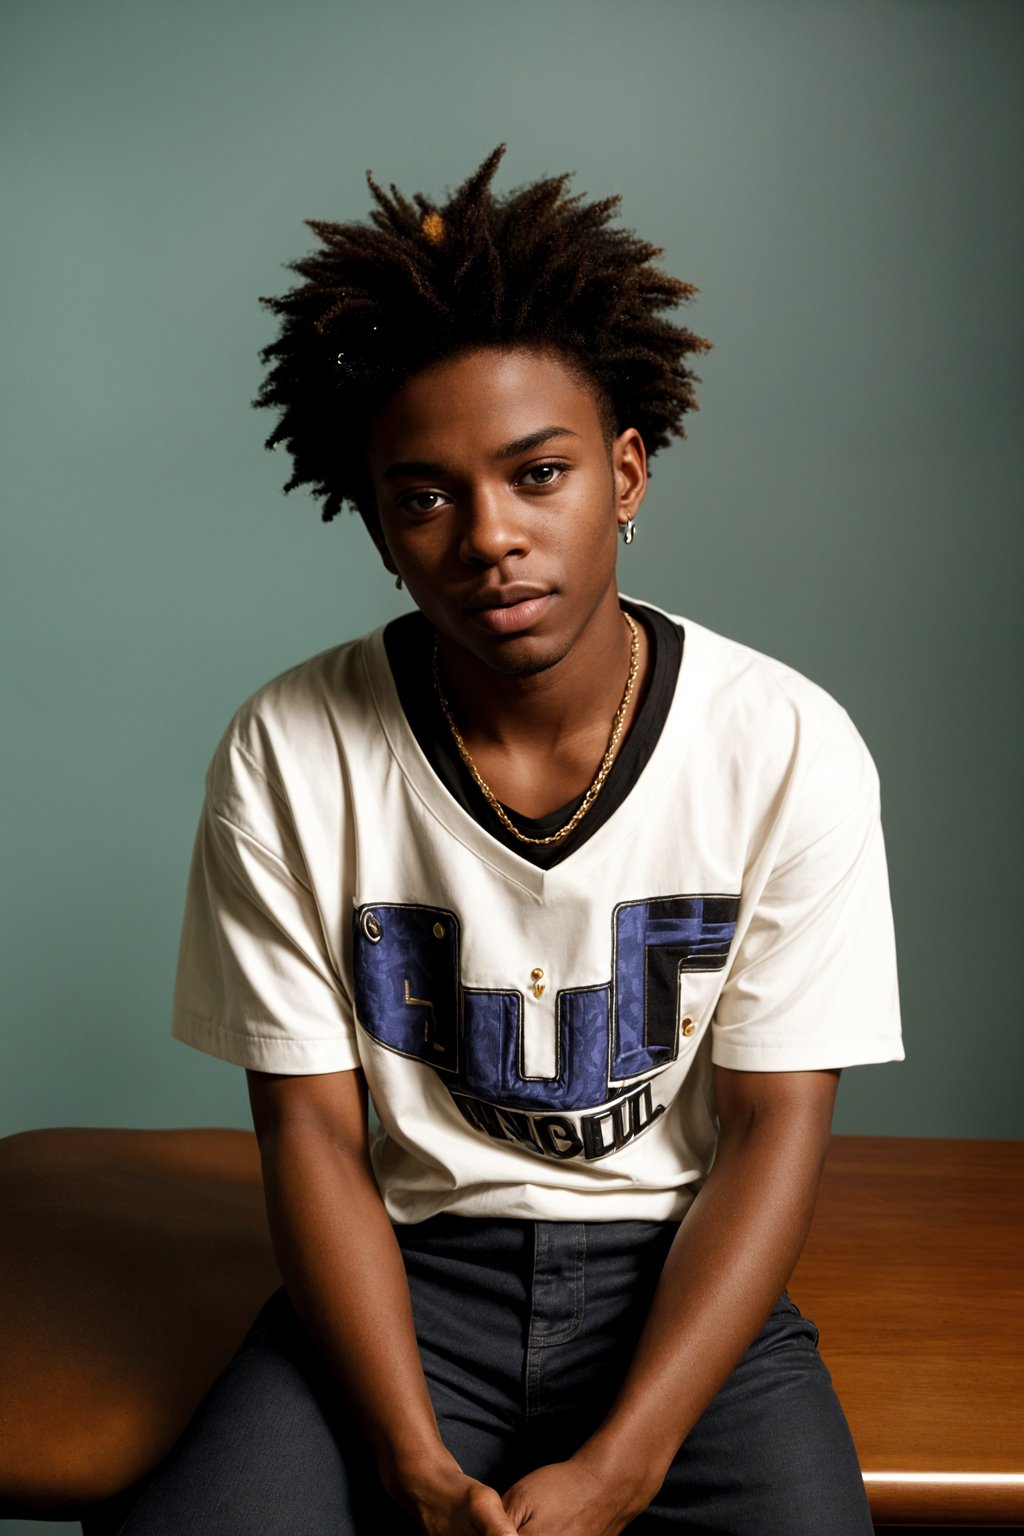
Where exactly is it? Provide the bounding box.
[172,736,359,1074]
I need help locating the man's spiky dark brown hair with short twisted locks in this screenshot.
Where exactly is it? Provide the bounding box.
[253,144,711,522]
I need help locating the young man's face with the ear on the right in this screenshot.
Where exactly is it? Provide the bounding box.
[368,347,646,674]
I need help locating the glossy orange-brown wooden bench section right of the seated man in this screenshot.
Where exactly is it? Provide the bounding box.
[789,1137,1024,1527]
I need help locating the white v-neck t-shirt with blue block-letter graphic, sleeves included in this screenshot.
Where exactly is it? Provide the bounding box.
[173,619,903,1221]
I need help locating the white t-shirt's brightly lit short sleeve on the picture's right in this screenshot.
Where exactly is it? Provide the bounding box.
[712,714,903,1072]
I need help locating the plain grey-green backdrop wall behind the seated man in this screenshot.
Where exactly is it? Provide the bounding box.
[0,0,1024,1530]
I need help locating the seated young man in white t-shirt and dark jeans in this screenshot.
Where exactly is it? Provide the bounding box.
[132,151,901,1536]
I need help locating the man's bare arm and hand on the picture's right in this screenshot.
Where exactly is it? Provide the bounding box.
[505,1068,838,1536]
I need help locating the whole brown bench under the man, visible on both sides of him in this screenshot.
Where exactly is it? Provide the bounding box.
[0,1130,1024,1536]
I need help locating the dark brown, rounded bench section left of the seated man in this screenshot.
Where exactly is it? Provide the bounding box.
[0,1127,281,1524]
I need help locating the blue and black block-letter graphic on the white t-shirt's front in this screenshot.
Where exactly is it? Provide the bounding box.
[353,895,738,1161]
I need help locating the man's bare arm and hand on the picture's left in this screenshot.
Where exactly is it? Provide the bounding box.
[247,1071,514,1536]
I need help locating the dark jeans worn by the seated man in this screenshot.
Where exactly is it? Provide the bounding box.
[104,1217,872,1536]
